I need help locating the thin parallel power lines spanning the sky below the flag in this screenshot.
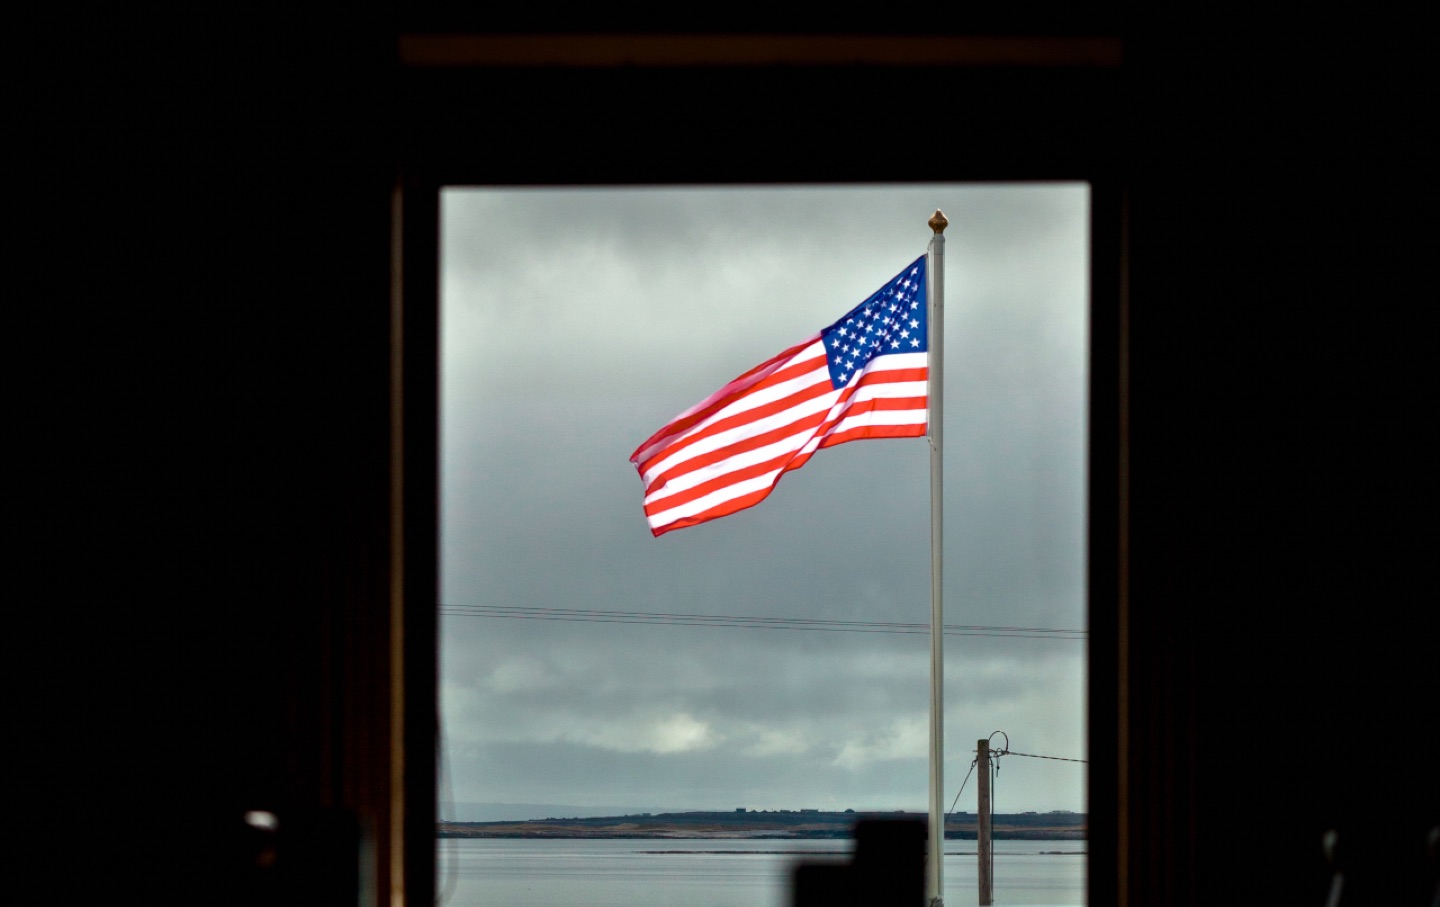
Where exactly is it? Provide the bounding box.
[441,605,1089,641]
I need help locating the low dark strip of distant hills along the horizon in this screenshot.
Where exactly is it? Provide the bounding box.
[436,809,1086,841]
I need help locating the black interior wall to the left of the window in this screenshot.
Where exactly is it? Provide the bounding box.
[21,24,411,904]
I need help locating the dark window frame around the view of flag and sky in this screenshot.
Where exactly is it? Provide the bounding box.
[392,36,1126,904]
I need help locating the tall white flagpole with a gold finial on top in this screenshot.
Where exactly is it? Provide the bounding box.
[924,209,950,907]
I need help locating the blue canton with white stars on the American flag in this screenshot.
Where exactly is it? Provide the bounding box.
[819,255,929,389]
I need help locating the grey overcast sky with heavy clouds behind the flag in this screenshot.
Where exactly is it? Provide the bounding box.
[441,183,1089,819]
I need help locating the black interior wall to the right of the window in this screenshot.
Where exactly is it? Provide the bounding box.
[1130,32,1437,903]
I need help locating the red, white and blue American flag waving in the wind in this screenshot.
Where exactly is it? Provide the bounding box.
[631,255,929,536]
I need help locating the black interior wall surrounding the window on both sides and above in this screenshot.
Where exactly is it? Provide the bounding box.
[14,22,1440,904]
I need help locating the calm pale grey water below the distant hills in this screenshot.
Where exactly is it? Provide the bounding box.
[436,838,1086,907]
